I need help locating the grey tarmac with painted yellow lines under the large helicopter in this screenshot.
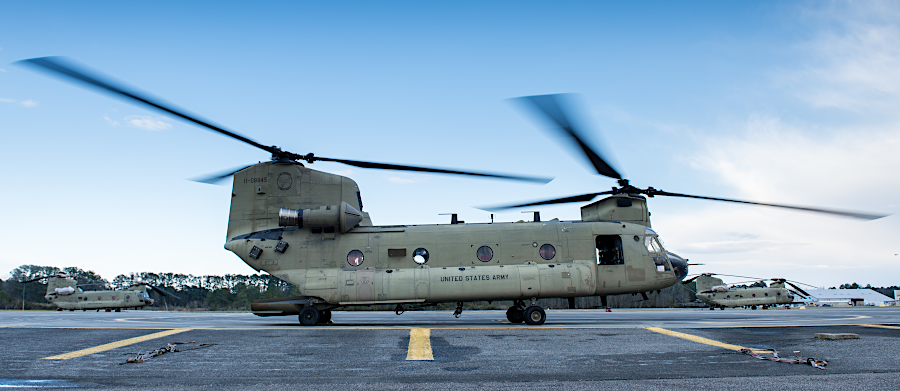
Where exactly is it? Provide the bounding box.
[0,308,900,390]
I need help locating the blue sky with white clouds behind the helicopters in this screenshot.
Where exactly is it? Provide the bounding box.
[0,1,900,286]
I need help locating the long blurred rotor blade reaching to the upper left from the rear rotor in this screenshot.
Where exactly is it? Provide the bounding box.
[18,57,276,154]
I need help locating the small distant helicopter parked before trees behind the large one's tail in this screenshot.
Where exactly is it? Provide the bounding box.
[22,272,179,312]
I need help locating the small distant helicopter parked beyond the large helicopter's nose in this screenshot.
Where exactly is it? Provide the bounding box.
[682,273,812,310]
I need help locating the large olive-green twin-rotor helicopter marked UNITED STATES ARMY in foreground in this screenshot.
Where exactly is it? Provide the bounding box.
[21,57,882,326]
